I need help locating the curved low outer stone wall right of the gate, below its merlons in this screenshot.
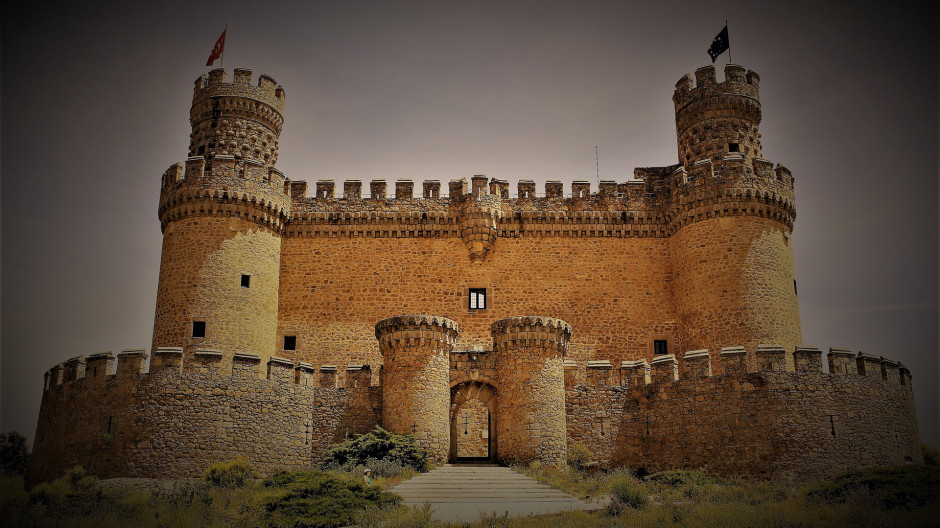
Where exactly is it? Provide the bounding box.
[566,348,923,478]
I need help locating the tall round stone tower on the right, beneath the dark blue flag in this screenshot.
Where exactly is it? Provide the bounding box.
[669,64,802,365]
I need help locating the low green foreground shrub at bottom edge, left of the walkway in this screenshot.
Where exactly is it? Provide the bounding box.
[263,471,400,528]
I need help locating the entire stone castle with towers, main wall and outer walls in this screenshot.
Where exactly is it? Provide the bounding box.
[28,64,922,482]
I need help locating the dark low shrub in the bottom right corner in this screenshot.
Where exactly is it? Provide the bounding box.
[807,466,940,510]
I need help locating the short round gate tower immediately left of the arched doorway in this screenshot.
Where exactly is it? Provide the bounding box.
[375,315,458,463]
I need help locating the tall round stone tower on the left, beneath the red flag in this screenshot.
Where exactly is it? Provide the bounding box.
[153,69,290,365]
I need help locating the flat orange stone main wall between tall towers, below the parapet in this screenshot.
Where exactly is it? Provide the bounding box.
[276,236,676,382]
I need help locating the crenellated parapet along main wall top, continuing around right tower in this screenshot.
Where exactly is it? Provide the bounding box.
[285,163,796,239]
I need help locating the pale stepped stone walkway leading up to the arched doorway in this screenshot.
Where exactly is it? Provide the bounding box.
[390,464,604,522]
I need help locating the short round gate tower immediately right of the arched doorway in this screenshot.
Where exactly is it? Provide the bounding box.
[490,317,571,466]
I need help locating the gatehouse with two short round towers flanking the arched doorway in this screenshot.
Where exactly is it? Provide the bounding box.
[375,314,571,465]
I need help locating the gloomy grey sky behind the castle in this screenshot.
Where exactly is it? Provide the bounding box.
[0,0,940,445]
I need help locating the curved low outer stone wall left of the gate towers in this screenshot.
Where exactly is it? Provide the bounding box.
[27,355,381,485]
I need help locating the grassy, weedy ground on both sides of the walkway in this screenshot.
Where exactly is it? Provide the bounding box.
[0,464,940,528]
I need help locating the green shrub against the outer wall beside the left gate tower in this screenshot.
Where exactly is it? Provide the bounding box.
[322,427,428,476]
